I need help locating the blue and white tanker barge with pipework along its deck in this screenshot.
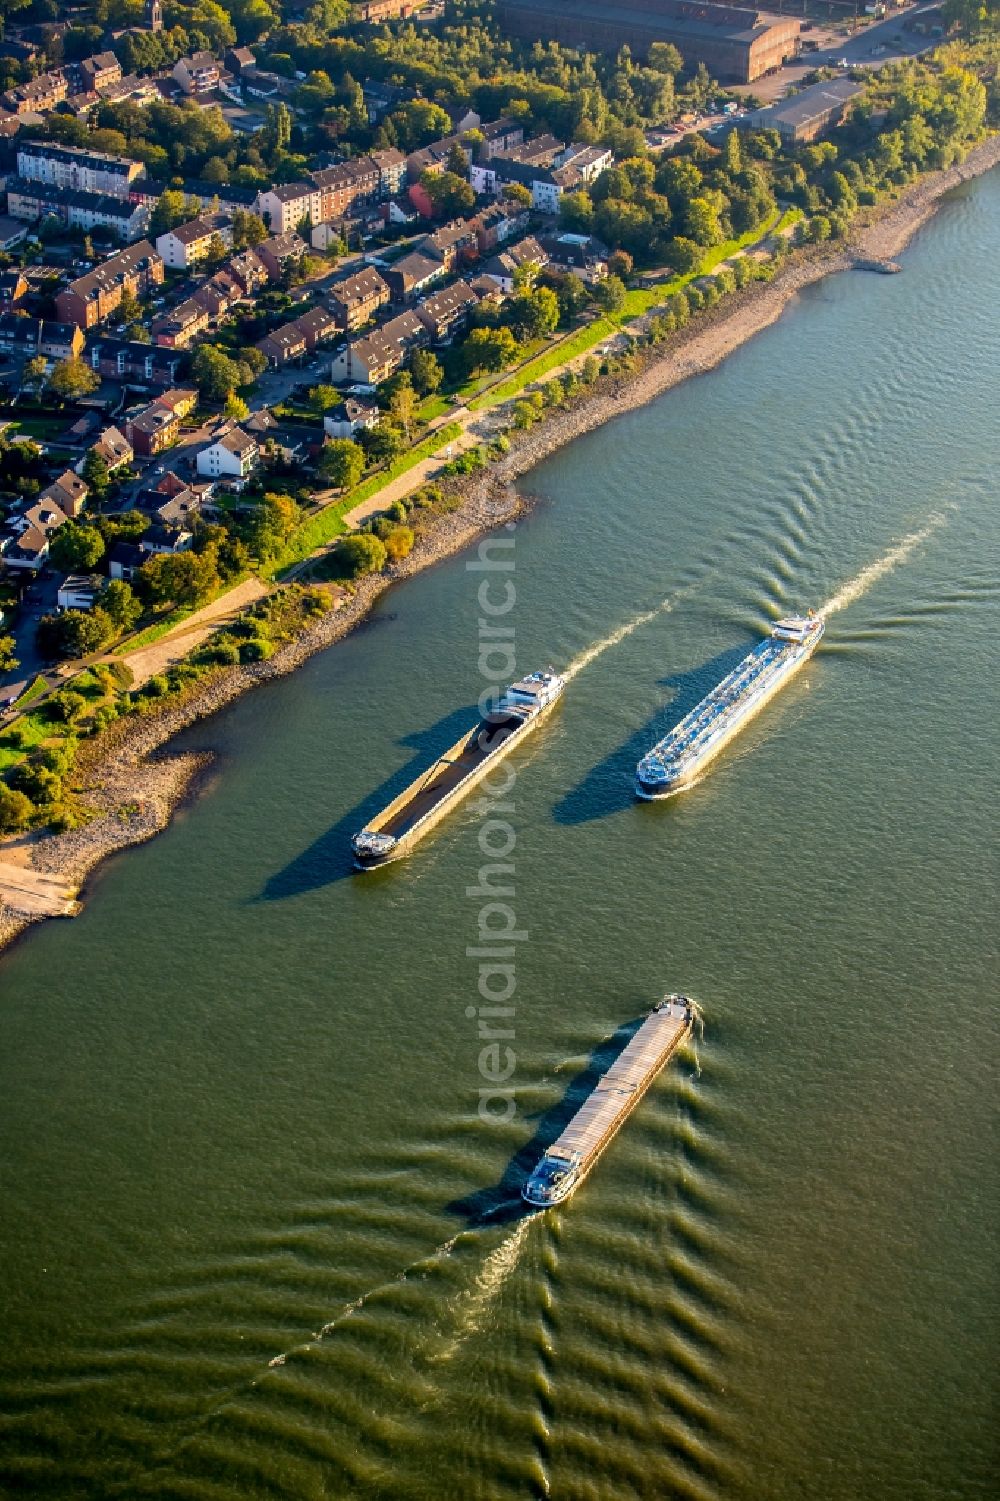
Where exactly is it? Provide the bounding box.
[635,611,824,802]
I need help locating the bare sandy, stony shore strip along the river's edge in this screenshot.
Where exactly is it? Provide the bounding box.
[0,137,1000,947]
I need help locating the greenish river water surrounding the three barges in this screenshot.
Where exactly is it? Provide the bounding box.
[0,173,1000,1501]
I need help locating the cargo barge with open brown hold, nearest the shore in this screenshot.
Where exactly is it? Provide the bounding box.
[351,668,566,871]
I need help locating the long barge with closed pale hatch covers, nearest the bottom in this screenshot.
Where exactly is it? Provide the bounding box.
[521,995,694,1210]
